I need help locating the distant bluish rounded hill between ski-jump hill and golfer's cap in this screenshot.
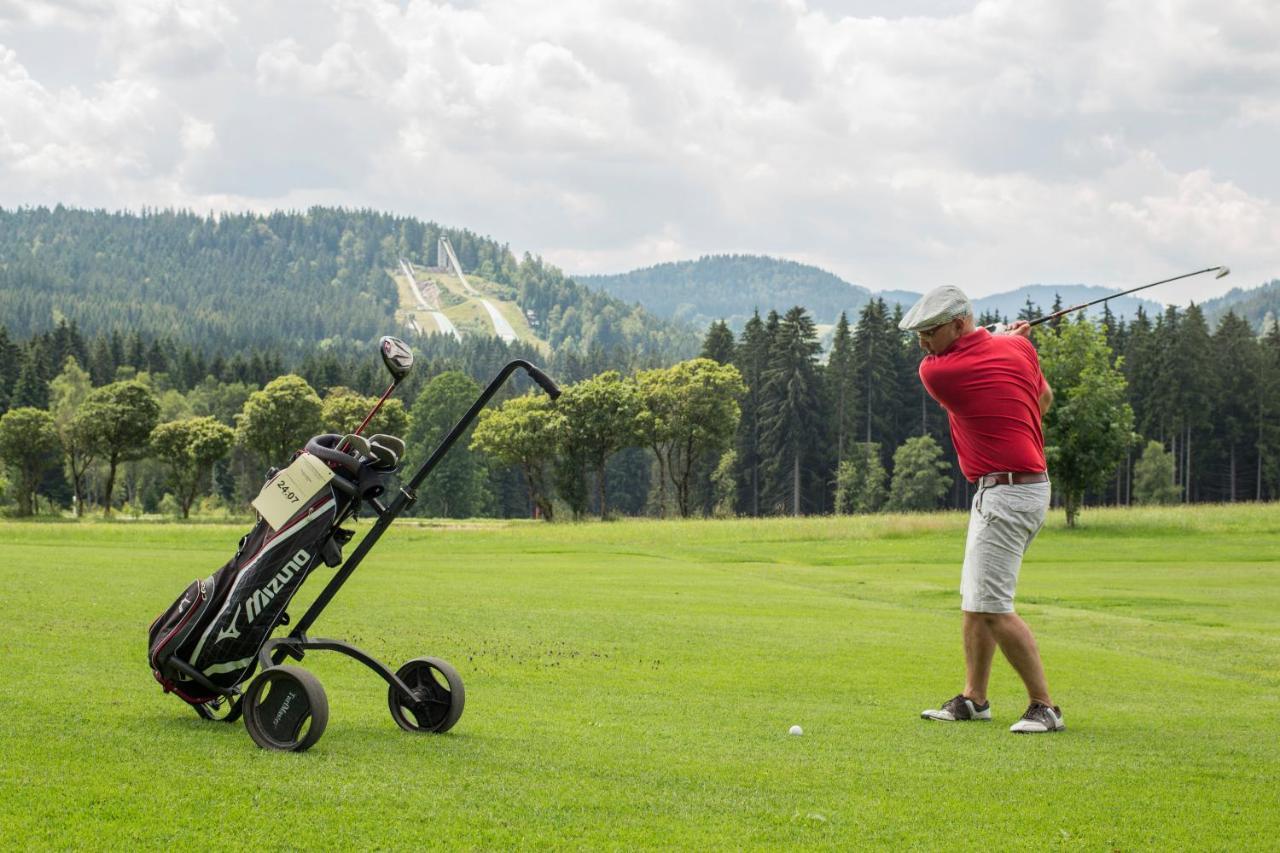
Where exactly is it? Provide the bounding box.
[575,255,872,328]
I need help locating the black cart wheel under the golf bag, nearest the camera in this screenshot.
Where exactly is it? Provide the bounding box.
[241,666,329,752]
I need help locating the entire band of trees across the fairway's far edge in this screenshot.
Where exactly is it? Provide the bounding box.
[0,292,1280,520]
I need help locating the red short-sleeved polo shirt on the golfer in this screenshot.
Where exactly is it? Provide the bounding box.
[920,328,1048,483]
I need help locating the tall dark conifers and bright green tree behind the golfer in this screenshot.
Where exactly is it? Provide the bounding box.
[704,298,1280,515]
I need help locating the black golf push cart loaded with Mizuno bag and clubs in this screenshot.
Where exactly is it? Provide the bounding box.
[147,337,559,752]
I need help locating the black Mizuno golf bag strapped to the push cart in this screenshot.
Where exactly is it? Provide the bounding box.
[147,435,394,706]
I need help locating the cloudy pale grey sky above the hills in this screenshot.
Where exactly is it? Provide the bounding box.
[0,0,1280,302]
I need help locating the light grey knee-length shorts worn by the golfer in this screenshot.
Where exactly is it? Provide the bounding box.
[960,483,1050,613]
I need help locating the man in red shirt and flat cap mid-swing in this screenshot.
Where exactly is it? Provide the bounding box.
[900,286,1066,733]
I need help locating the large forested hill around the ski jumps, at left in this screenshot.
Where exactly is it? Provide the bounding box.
[0,206,696,357]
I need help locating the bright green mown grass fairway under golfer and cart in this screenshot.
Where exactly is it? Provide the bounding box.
[0,506,1280,850]
